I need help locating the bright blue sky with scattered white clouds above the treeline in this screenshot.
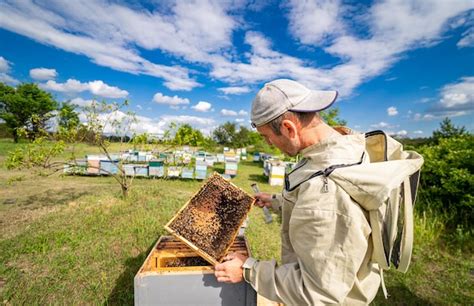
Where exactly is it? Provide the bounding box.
[0,0,474,137]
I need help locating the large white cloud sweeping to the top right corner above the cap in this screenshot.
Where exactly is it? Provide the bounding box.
[282,0,474,95]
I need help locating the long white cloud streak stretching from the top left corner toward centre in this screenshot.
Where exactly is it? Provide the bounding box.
[0,1,203,90]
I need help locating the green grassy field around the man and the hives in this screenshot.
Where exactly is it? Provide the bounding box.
[0,140,474,305]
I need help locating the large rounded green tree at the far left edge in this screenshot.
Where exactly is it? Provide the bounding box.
[0,83,57,142]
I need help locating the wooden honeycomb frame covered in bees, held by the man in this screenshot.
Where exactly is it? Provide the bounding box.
[165,173,255,265]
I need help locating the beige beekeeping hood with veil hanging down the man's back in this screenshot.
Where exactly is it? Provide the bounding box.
[323,130,423,298]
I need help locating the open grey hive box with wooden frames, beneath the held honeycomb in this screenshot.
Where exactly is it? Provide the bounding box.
[134,236,257,306]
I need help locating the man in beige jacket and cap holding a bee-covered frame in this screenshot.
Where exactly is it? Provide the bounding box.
[215,79,381,305]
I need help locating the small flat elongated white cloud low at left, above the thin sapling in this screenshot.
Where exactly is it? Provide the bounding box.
[40,79,128,98]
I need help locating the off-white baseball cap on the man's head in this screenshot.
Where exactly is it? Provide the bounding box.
[250,79,337,127]
